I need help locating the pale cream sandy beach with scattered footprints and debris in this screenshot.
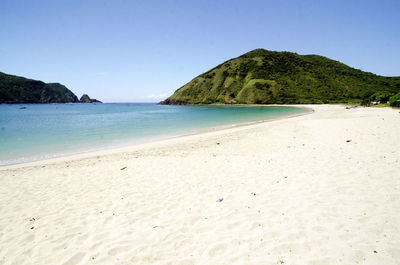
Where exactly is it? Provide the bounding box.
[0,105,400,264]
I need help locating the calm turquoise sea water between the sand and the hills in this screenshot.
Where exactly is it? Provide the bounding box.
[0,103,309,165]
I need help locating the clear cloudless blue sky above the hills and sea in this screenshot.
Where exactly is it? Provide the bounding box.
[0,0,400,102]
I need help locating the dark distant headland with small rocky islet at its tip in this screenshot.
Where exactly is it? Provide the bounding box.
[0,72,101,104]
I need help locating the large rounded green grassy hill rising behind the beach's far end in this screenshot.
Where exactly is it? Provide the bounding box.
[160,49,400,104]
